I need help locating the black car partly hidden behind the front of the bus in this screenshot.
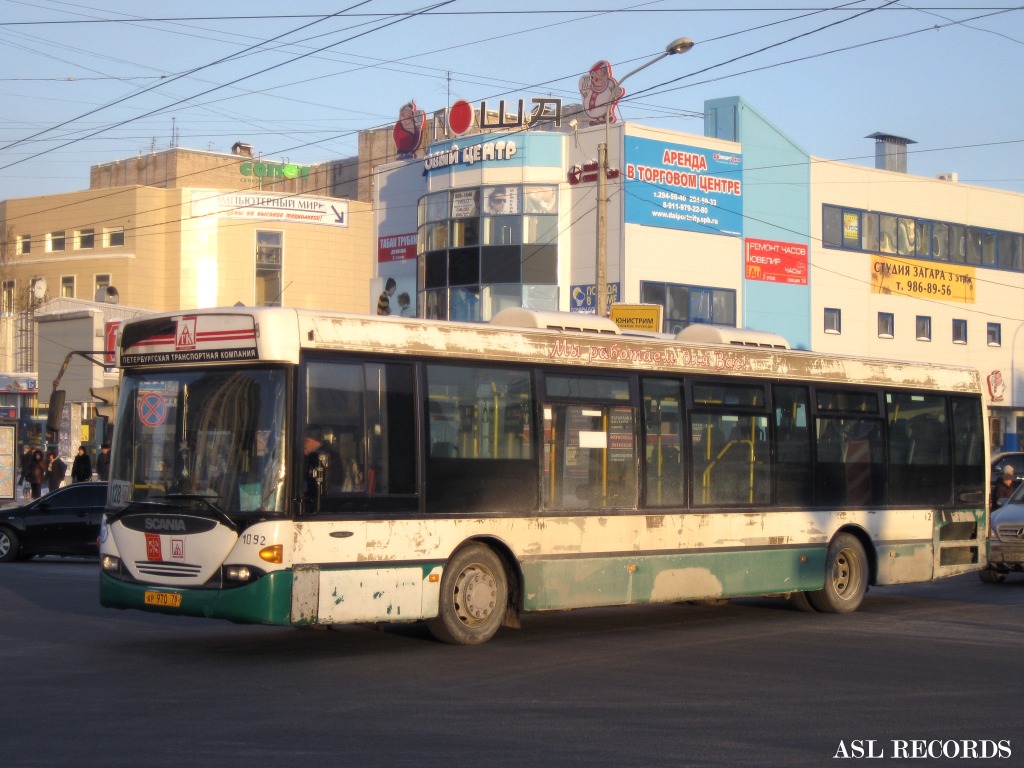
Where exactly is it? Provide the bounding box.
[0,482,106,562]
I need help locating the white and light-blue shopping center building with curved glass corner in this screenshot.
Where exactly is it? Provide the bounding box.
[373,97,1024,450]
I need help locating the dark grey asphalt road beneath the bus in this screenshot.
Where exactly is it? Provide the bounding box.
[0,559,1024,768]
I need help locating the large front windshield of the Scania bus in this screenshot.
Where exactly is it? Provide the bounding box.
[110,369,286,518]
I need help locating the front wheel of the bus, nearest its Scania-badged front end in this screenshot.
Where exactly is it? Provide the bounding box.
[427,544,509,645]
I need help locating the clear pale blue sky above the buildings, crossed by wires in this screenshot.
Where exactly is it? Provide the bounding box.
[0,0,1024,204]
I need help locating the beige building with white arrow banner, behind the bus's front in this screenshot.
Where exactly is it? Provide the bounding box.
[0,148,375,325]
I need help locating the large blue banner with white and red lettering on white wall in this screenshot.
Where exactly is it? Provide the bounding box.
[625,136,743,237]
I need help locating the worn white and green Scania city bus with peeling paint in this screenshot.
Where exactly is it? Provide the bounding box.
[100,308,988,644]
